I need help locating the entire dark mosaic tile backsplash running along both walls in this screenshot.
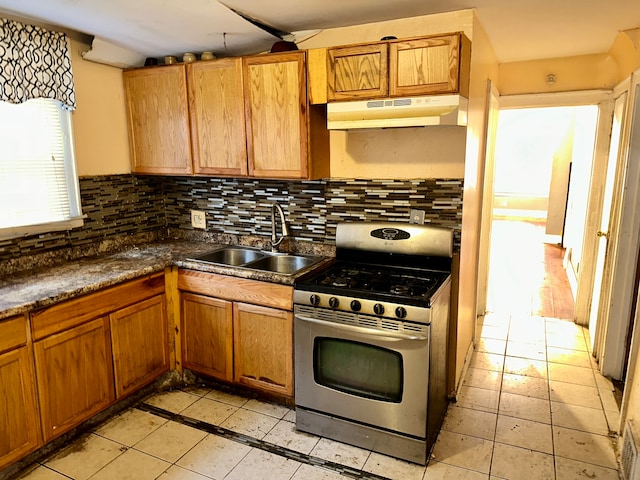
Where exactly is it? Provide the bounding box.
[0,175,463,261]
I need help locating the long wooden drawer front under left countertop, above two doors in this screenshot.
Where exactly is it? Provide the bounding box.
[31,273,164,340]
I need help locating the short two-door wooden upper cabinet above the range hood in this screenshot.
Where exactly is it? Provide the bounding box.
[327,32,471,102]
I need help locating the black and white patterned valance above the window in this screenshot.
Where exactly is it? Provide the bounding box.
[0,19,76,109]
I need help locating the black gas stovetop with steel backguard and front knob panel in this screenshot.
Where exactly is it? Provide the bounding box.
[294,222,453,320]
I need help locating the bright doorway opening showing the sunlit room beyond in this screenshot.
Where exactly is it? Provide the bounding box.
[486,105,598,321]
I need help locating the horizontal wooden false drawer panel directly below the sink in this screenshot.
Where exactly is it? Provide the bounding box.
[178,269,293,311]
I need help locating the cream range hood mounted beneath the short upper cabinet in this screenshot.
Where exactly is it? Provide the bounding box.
[327,95,468,130]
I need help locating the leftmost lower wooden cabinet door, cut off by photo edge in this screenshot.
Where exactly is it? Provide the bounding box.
[0,346,40,469]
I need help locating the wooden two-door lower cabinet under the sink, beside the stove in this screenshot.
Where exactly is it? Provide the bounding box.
[178,269,293,399]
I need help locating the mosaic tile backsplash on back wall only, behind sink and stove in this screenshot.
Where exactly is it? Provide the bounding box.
[163,177,463,251]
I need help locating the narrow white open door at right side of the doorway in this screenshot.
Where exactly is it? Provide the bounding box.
[589,92,627,355]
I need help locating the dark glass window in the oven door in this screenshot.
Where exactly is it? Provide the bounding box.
[313,337,404,403]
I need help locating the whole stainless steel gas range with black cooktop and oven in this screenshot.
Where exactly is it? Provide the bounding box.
[294,222,453,465]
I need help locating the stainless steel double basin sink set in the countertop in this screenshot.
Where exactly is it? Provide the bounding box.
[189,246,324,275]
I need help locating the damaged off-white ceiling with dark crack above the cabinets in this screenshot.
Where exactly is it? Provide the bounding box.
[0,0,640,67]
